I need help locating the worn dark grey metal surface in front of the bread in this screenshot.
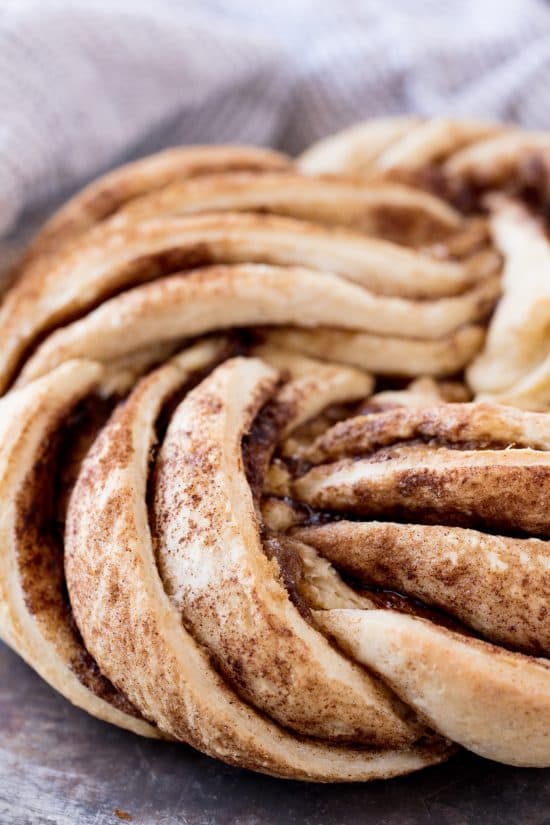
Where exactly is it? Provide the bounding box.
[0,644,550,825]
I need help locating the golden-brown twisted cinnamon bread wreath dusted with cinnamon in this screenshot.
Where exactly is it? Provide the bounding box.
[0,117,550,781]
